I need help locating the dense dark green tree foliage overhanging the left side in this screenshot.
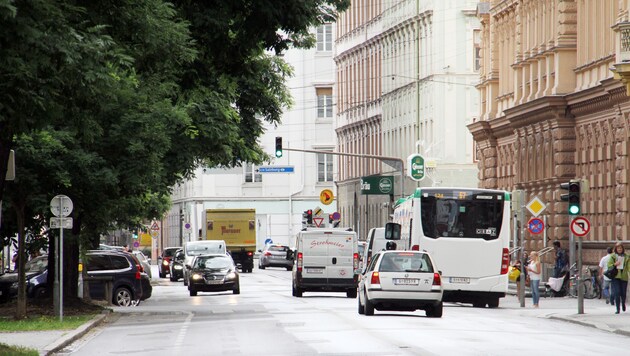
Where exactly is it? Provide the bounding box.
[0,0,349,314]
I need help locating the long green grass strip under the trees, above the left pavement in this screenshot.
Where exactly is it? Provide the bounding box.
[0,314,94,332]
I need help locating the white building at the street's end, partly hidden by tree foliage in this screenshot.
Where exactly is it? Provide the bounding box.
[163,24,337,249]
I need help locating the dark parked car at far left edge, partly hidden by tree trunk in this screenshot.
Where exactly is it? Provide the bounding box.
[0,255,48,301]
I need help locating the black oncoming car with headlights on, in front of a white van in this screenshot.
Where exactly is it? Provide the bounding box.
[188,254,241,297]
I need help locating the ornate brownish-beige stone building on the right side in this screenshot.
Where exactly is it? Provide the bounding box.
[468,0,630,262]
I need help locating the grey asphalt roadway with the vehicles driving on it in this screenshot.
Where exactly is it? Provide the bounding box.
[58,266,630,355]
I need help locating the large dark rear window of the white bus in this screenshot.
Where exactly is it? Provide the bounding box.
[420,190,505,240]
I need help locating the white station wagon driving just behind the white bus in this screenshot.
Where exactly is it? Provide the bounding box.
[358,251,443,318]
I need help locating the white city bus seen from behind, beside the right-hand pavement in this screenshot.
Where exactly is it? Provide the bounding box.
[385,187,511,308]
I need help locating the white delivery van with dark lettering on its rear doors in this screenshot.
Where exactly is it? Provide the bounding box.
[292,228,360,298]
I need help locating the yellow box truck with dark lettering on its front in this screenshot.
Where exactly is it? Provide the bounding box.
[204,209,256,273]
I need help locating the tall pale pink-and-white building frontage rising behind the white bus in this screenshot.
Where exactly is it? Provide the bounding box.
[335,0,481,236]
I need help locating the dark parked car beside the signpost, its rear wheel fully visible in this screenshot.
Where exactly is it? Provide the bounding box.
[86,250,152,306]
